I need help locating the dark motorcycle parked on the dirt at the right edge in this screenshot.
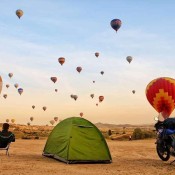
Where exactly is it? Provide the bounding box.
[154,118,175,163]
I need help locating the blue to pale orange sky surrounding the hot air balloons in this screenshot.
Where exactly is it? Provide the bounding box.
[0,0,175,125]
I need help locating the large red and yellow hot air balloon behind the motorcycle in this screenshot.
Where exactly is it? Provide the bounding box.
[146,77,175,119]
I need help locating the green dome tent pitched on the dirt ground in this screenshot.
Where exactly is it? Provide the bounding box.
[43,117,112,163]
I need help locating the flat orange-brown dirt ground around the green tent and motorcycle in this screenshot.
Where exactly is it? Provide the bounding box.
[0,140,175,175]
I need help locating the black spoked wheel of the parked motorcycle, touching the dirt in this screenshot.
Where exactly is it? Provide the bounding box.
[156,144,170,161]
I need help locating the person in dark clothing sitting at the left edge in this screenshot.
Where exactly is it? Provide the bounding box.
[0,123,15,148]
